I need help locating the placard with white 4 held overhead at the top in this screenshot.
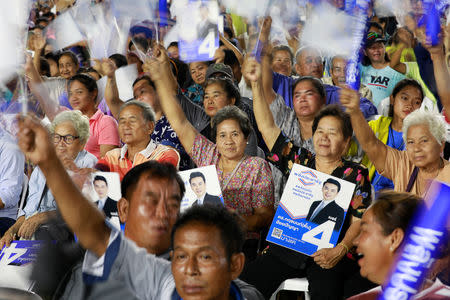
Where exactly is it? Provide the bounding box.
[177,0,219,62]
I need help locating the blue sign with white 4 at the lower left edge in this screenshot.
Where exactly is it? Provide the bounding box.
[0,241,45,266]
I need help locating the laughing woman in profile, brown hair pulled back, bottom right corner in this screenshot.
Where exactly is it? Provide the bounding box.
[350,191,448,300]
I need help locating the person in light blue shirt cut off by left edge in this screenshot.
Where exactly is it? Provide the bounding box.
[0,127,25,236]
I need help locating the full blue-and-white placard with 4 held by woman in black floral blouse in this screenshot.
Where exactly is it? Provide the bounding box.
[267,164,355,255]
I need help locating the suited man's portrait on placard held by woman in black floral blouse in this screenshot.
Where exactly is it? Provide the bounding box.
[306,178,344,231]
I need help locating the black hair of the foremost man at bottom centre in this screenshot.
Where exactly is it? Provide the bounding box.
[171,204,245,262]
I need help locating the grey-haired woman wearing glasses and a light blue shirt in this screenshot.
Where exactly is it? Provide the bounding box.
[0,111,97,248]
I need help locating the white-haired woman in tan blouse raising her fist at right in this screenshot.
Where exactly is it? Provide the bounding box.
[341,89,450,196]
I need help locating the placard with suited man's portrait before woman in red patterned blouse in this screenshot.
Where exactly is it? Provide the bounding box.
[178,165,223,212]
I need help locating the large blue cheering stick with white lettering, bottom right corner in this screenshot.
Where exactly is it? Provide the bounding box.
[379,182,450,300]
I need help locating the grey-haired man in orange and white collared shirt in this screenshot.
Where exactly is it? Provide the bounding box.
[97,100,180,180]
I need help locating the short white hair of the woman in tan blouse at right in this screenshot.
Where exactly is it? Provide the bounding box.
[402,109,446,146]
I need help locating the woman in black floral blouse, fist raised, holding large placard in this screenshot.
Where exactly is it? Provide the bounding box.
[241,59,371,299]
